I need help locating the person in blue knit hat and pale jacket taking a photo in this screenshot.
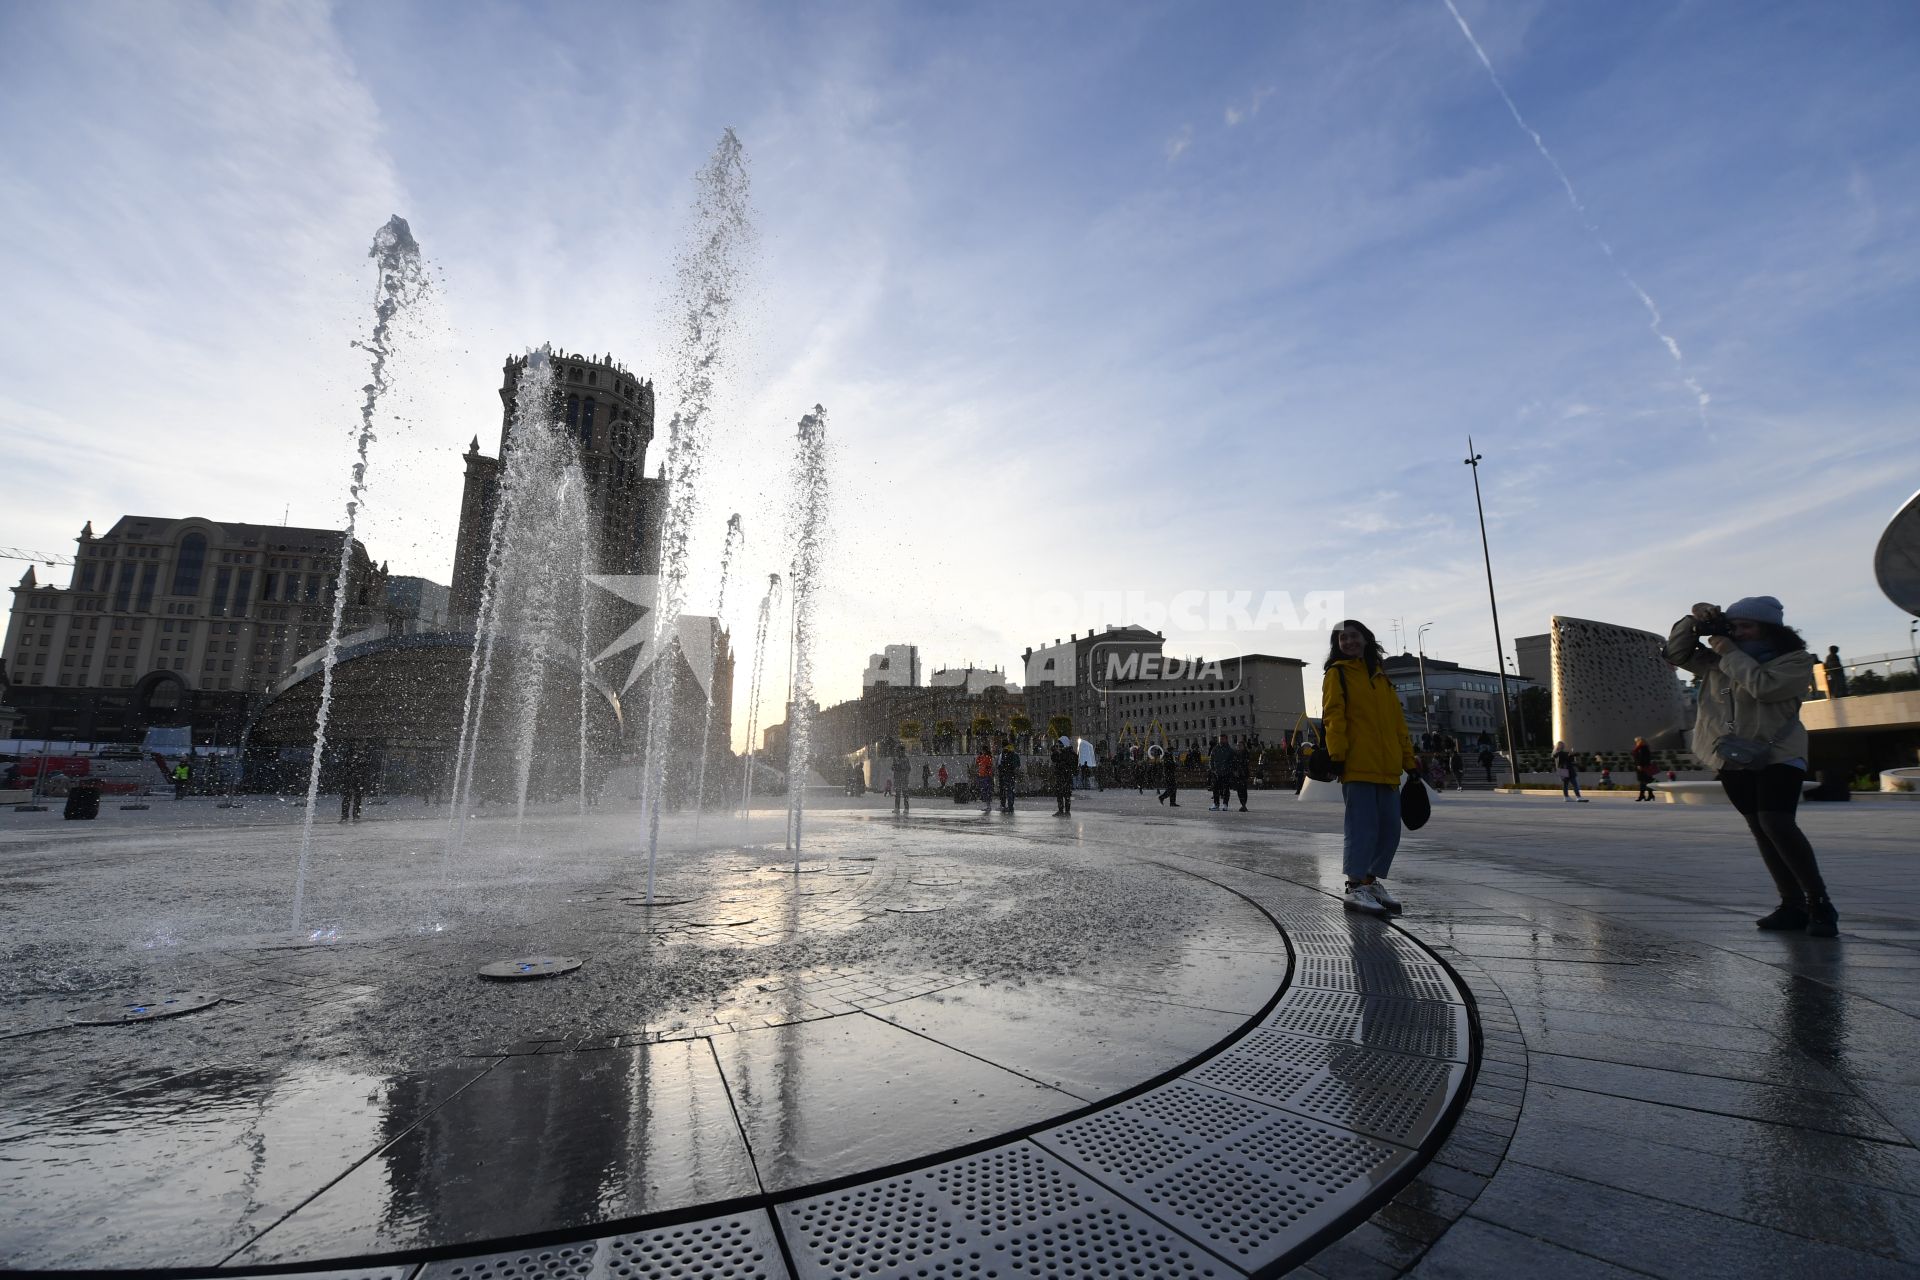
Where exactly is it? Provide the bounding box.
[1667,595,1839,938]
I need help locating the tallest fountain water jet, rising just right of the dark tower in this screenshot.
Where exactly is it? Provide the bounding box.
[641,129,753,902]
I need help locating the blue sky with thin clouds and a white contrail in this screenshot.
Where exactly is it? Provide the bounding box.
[0,0,1920,740]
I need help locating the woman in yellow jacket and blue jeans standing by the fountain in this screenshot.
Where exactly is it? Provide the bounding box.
[1321,618,1419,915]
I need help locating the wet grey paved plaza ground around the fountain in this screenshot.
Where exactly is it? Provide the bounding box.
[0,791,1920,1280]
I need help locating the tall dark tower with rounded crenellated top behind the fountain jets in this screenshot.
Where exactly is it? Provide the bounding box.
[449,351,666,628]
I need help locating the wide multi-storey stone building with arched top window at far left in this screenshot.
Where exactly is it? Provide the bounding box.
[6,516,388,743]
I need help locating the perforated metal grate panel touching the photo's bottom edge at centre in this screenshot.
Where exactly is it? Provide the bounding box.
[780,1142,1233,1278]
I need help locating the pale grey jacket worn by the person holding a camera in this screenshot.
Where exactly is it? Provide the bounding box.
[1667,614,1814,770]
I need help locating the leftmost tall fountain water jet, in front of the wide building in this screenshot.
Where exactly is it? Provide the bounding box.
[294,213,428,929]
